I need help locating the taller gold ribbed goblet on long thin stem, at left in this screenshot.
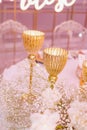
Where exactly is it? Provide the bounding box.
[23,30,45,103]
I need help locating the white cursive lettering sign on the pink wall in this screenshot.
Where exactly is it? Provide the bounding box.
[0,0,76,12]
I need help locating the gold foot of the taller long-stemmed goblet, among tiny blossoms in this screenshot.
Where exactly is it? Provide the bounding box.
[22,93,37,104]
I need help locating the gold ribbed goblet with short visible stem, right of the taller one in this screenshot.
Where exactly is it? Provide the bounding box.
[43,48,68,89]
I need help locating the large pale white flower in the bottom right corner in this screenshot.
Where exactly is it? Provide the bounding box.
[69,101,87,130]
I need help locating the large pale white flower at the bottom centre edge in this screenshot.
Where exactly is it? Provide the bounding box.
[30,110,59,130]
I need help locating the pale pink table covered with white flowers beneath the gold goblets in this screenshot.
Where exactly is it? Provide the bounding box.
[0,51,87,130]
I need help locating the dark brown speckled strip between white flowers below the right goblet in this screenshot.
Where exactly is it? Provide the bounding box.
[55,83,75,130]
